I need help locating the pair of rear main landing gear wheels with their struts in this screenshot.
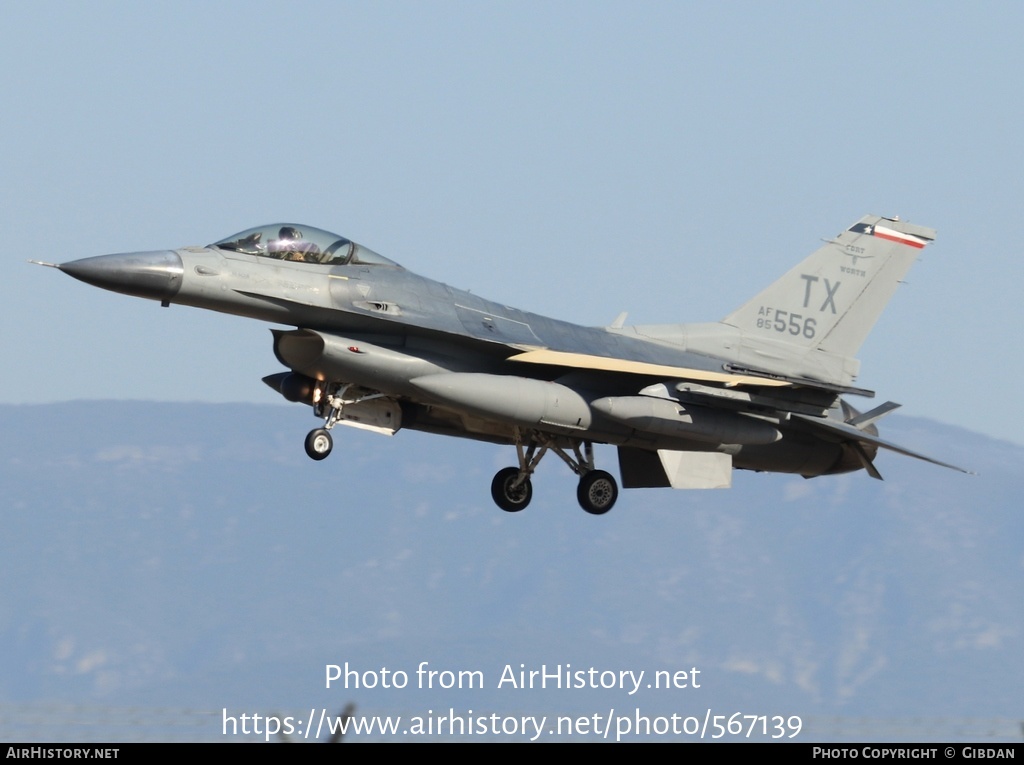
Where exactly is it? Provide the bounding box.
[490,428,618,515]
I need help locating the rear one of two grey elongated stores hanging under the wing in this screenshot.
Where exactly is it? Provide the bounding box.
[590,395,782,444]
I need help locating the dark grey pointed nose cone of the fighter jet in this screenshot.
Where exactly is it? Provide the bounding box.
[57,250,184,301]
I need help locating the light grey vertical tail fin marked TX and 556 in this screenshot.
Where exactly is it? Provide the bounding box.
[722,215,935,358]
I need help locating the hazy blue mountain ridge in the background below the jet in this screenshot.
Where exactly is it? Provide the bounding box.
[0,401,1024,734]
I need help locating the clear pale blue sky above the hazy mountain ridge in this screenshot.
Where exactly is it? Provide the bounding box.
[0,2,1024,442]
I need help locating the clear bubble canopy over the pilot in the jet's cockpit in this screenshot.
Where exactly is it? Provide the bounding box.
[210,223,400,267]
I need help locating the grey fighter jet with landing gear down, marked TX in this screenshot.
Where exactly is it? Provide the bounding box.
[44,215,967,515]
